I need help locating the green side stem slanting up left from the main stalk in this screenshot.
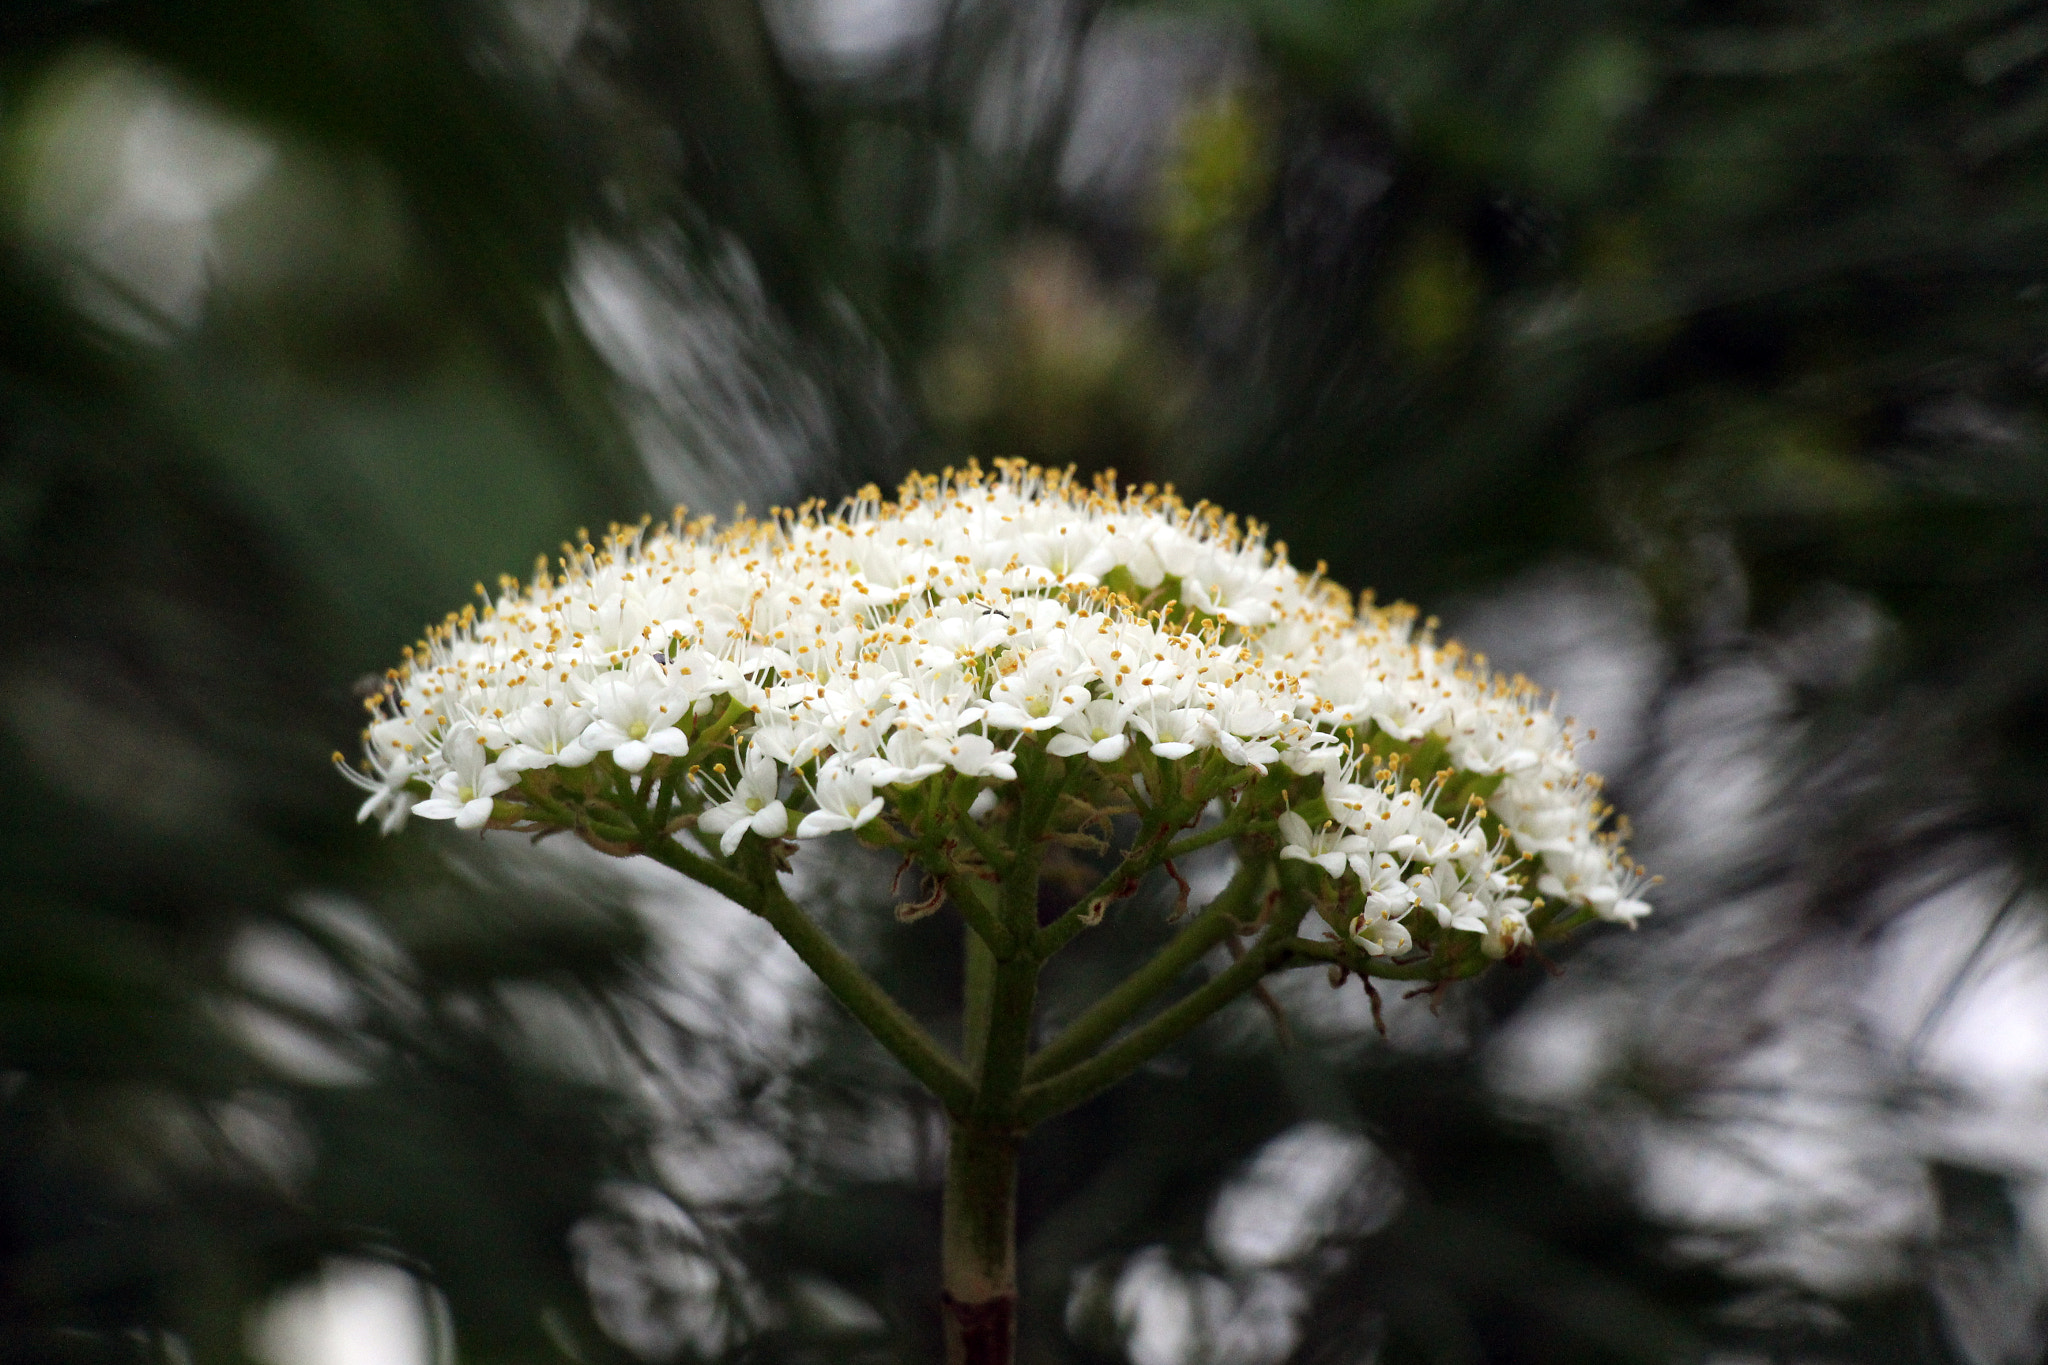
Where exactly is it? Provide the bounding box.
[647,839,975,1113]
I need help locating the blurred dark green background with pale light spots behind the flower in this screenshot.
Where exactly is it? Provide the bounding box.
[0,0,2048,1365]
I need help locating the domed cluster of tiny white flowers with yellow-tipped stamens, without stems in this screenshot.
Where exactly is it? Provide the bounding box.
[335,463,1649,958]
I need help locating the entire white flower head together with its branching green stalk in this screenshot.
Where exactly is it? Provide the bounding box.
[344,463,1649,1365]
